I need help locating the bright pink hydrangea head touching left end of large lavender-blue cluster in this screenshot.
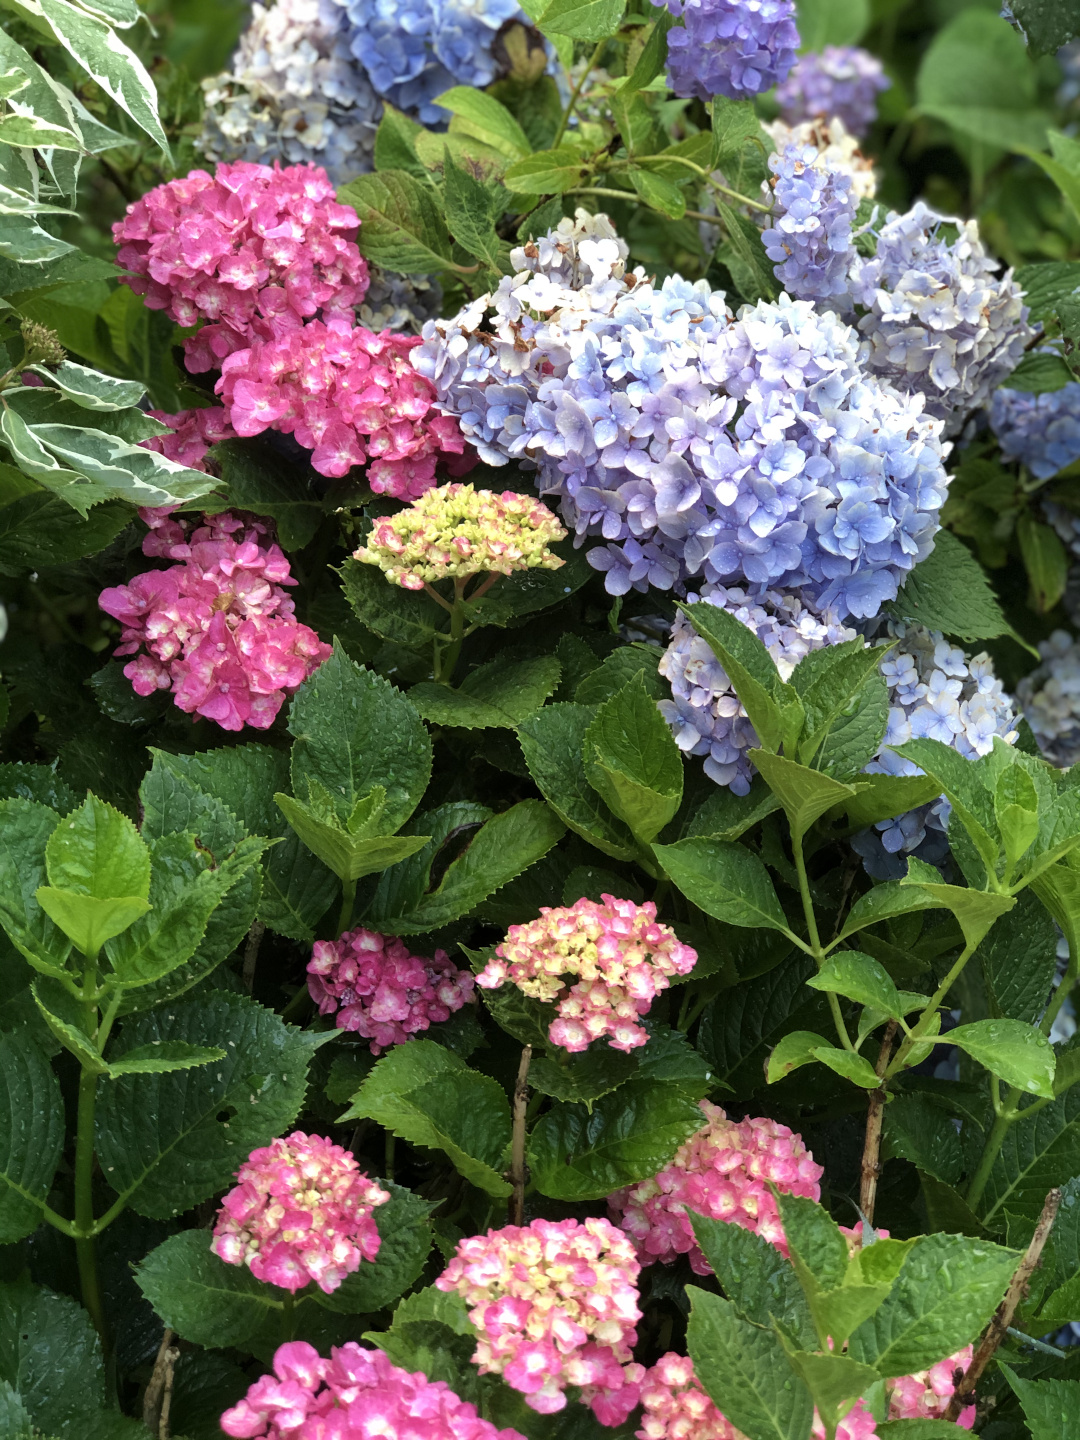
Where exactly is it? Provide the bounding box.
[216,315,472,486]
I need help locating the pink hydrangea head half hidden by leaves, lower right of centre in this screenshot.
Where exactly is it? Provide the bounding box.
[608,1100,824,1274]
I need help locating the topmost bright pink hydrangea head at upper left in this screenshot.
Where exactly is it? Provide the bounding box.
[112,160,367,372]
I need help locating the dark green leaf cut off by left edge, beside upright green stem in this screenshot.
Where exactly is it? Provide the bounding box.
[0,1031,65,1244]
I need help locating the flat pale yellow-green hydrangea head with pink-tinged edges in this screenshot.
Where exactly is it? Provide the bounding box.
[356,484,576,590]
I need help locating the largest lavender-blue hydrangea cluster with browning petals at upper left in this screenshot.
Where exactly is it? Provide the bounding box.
[413,212,946,616]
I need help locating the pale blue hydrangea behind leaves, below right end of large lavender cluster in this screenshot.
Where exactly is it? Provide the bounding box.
[851,624,1017,880]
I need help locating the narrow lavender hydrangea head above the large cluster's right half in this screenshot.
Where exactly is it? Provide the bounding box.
[762,144,858,300]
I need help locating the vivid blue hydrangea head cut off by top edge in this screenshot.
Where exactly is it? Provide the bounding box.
[334,0,528,125]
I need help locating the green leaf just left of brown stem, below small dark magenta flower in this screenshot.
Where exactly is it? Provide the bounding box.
[341,1040,510,1197]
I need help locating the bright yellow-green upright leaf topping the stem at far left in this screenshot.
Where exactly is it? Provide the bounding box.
[45,795,150,900]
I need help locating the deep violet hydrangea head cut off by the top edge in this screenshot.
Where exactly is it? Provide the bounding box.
[667,0,799,99]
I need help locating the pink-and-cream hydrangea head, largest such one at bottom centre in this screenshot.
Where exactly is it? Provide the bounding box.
[435,1218,641,1424]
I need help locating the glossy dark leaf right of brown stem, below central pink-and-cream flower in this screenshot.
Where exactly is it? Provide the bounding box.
[528,1079,701,1201]
